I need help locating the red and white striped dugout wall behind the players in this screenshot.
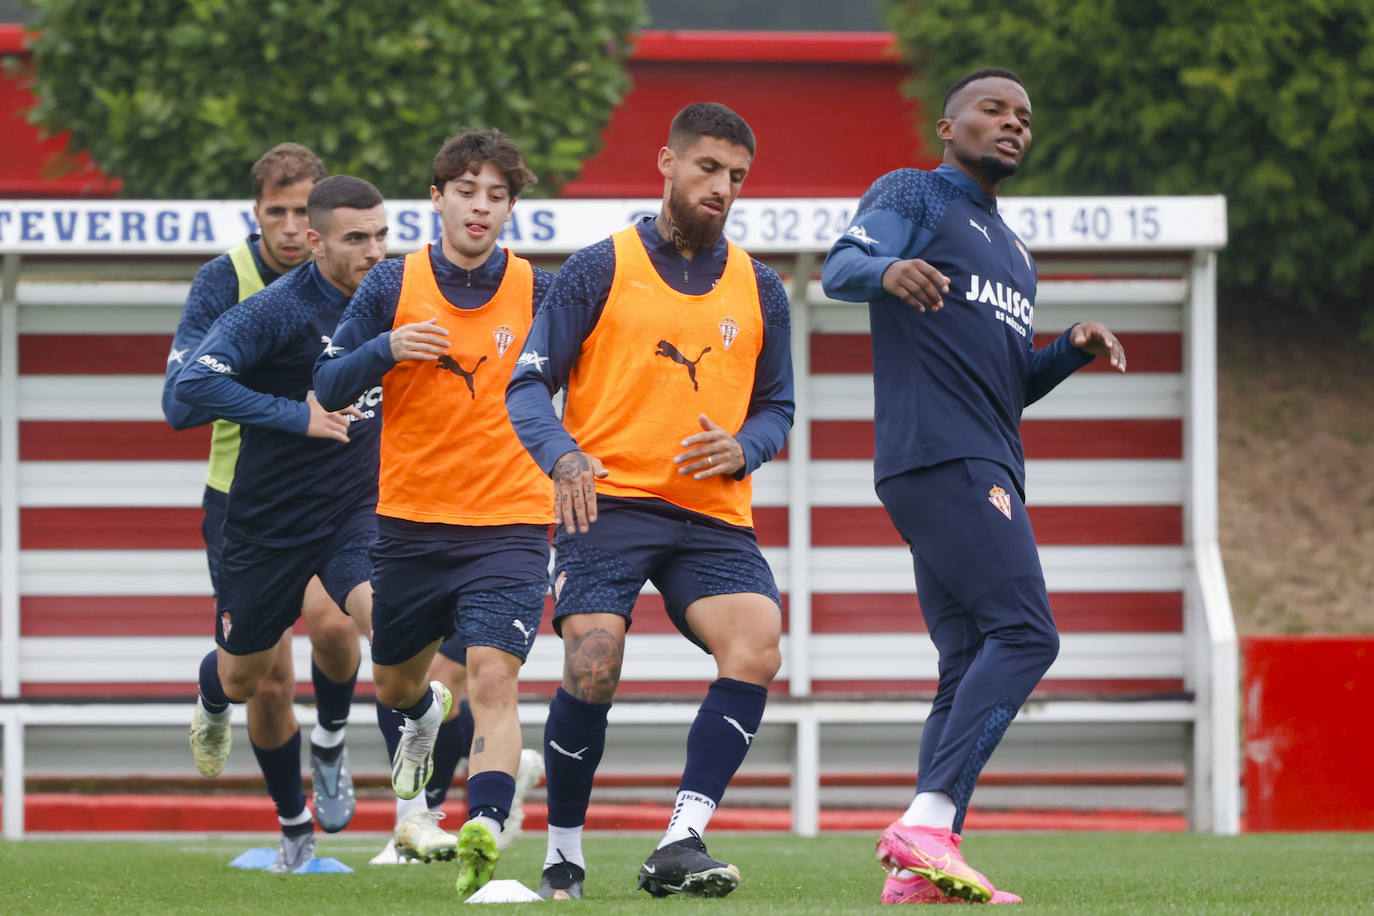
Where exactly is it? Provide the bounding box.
[0,199,1235,829]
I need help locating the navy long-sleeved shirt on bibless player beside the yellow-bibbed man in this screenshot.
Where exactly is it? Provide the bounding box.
[174,261,382,547]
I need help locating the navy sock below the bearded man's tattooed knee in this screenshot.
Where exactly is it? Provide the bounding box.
[544,687,610,827]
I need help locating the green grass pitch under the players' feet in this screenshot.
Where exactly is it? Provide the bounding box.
[0,832,1374,916]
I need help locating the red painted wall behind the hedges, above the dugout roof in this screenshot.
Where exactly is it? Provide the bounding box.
[0,25,938,198]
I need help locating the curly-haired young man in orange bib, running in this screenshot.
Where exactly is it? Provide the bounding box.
[315,129,554,894]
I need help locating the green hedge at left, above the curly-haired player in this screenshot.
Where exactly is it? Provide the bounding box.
[20,0,643,198]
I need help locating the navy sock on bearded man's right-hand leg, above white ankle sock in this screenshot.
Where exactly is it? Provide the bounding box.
[679,677,768,805]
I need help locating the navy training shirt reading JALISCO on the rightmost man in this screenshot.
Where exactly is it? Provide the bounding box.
[822,165,1092,497]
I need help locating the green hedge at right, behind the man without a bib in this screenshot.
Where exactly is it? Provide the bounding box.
[883,0,1374,334]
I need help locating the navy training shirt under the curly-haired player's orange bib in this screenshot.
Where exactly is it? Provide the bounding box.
[315,244,554,409]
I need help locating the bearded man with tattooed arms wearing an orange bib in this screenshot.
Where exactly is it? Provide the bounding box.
[507,103,793,898]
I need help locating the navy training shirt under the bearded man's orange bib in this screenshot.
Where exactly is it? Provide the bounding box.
[506,217,796,483]
